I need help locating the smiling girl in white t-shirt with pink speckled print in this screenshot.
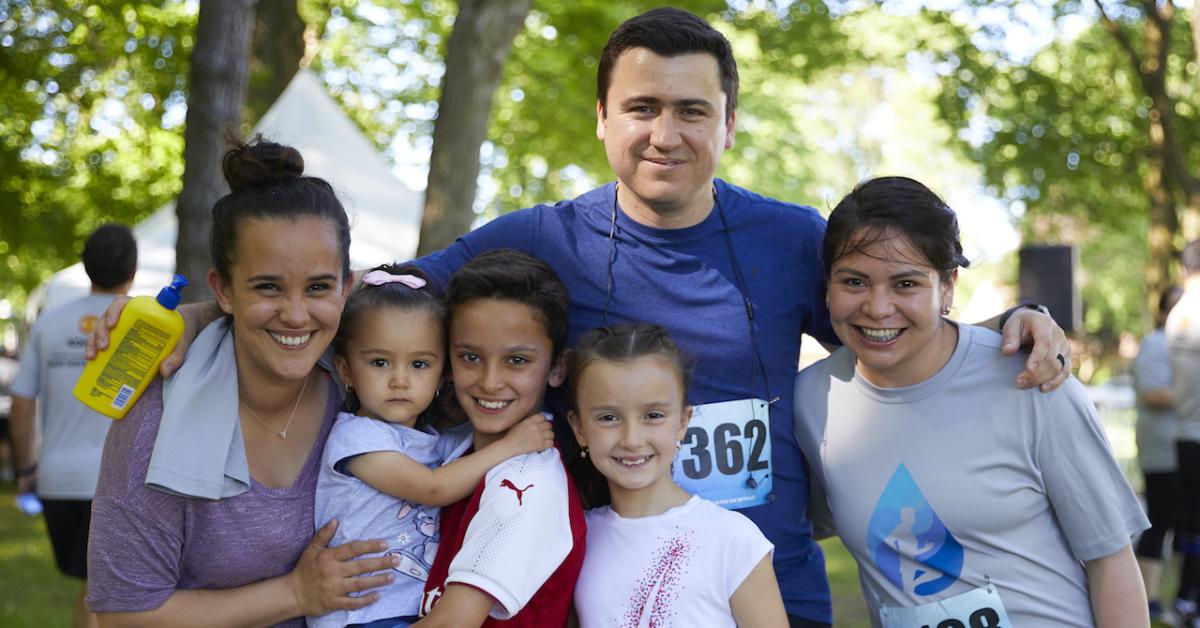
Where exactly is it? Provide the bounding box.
[568,324,787,628]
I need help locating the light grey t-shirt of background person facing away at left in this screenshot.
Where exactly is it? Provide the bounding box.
[12,294,113,500]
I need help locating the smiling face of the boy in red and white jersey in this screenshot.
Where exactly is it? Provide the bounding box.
[449,299,563,449]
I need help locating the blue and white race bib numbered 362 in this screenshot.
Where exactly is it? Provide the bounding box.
[674,399,773,509]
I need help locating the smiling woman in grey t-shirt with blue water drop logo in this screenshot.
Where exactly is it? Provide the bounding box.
[796,177,1150,628]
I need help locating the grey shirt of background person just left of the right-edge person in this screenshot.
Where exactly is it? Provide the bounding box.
[1133,329,1178,473]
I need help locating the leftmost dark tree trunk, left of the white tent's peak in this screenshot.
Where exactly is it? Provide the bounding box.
[175,0,256,301]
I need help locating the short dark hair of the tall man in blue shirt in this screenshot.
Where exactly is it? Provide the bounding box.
[596,7,738,119]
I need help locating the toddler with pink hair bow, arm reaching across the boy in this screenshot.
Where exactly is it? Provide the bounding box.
[308,265,554,628]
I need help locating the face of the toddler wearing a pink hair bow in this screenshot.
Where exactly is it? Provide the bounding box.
[334,307,445,427]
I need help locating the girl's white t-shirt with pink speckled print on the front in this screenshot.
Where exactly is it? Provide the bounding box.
[575,496,773,628]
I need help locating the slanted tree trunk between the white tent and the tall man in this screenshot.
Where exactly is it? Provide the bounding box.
[416,0,532,255]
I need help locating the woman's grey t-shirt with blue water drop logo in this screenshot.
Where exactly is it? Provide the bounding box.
[796,325,1148,628]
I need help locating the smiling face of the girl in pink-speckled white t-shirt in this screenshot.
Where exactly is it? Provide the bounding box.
[569,355,691,512]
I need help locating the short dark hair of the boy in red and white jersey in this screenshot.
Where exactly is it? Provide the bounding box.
[446,249,571,360]
